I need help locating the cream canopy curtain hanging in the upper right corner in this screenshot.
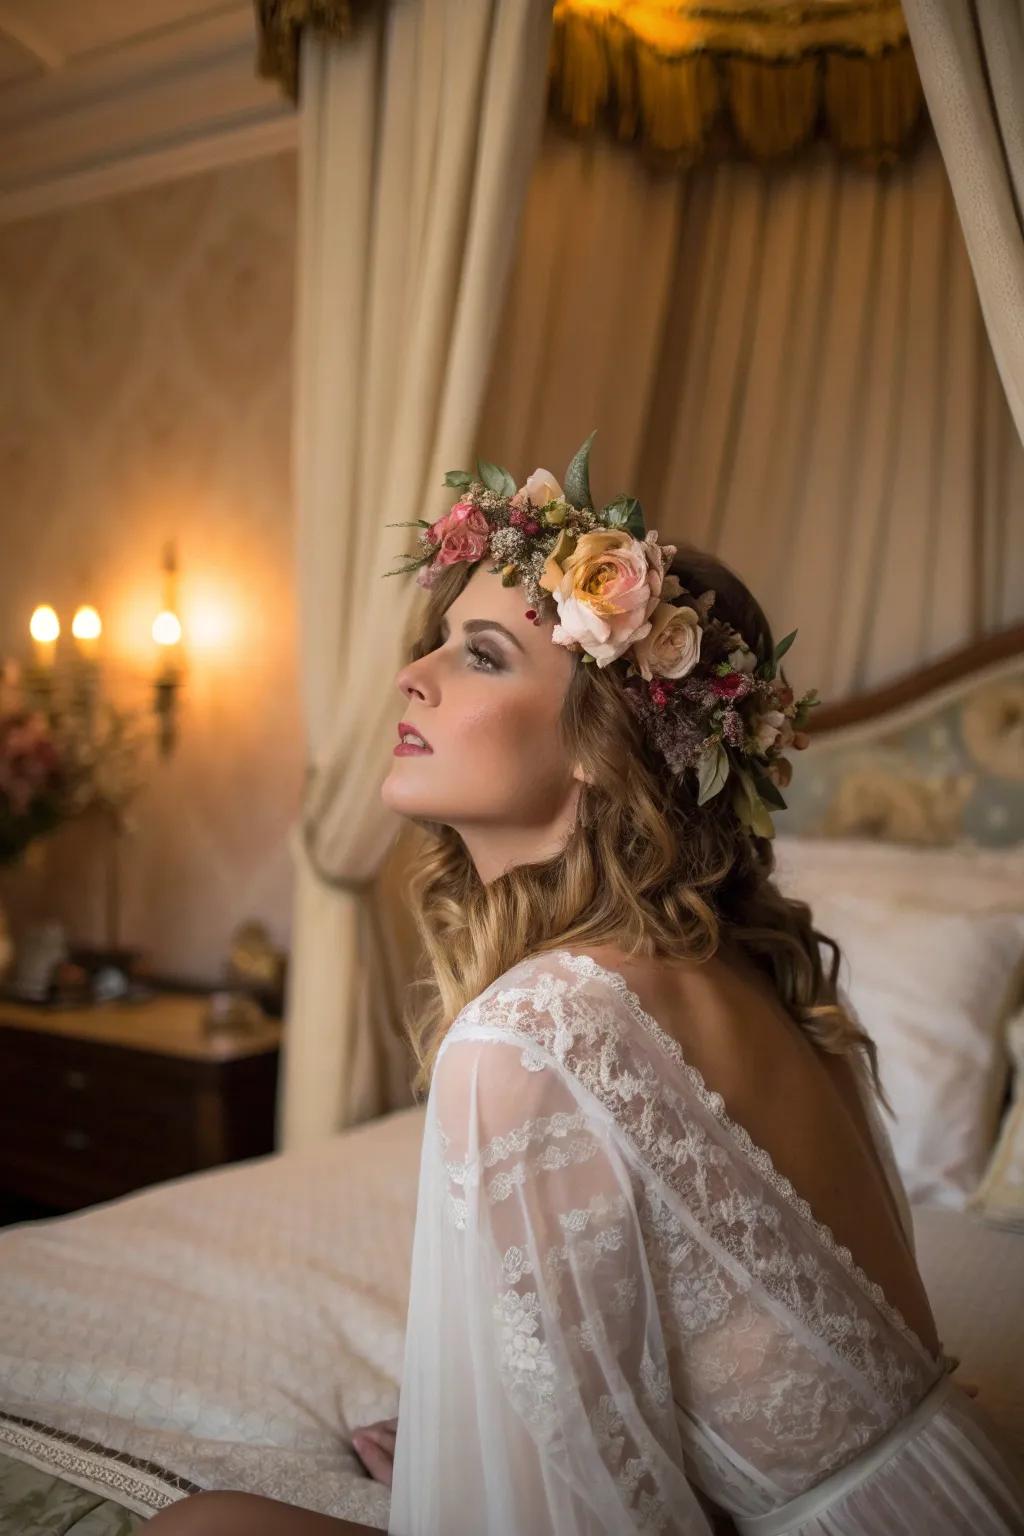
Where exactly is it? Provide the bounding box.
[904,0,1024,439]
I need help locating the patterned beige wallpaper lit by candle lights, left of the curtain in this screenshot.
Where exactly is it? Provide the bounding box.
[0,152,302,980]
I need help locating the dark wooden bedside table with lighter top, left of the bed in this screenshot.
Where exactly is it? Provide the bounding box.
[0,992,281,1210]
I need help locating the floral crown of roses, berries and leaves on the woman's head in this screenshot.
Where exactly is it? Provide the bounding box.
[385,432,817,837]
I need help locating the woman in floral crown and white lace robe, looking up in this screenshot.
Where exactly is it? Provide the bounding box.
[145,435,1024,1536]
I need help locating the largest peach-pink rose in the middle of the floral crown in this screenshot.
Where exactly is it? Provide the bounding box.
[540,528,663,667]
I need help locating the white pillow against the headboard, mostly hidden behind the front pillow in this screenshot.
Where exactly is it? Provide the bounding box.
[774,834,1024,912]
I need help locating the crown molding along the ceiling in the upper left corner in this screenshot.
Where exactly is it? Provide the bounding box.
[0,5,298,224]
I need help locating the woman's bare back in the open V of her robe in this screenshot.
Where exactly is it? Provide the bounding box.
[564,945,940,1353]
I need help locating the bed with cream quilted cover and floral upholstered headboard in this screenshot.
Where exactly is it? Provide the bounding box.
[0,631,1024,1536]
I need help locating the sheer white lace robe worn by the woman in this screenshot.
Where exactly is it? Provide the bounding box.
[388,951,1024,1536]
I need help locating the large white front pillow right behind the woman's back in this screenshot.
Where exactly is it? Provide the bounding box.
[812,894,1024,1207]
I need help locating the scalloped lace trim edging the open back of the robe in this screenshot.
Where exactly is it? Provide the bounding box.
[545,949,952,1370]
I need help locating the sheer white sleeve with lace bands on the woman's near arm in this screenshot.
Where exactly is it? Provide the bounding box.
[388,1031,712,1536]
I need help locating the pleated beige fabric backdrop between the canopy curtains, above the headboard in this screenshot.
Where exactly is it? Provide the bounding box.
[479,119,1024,699]
